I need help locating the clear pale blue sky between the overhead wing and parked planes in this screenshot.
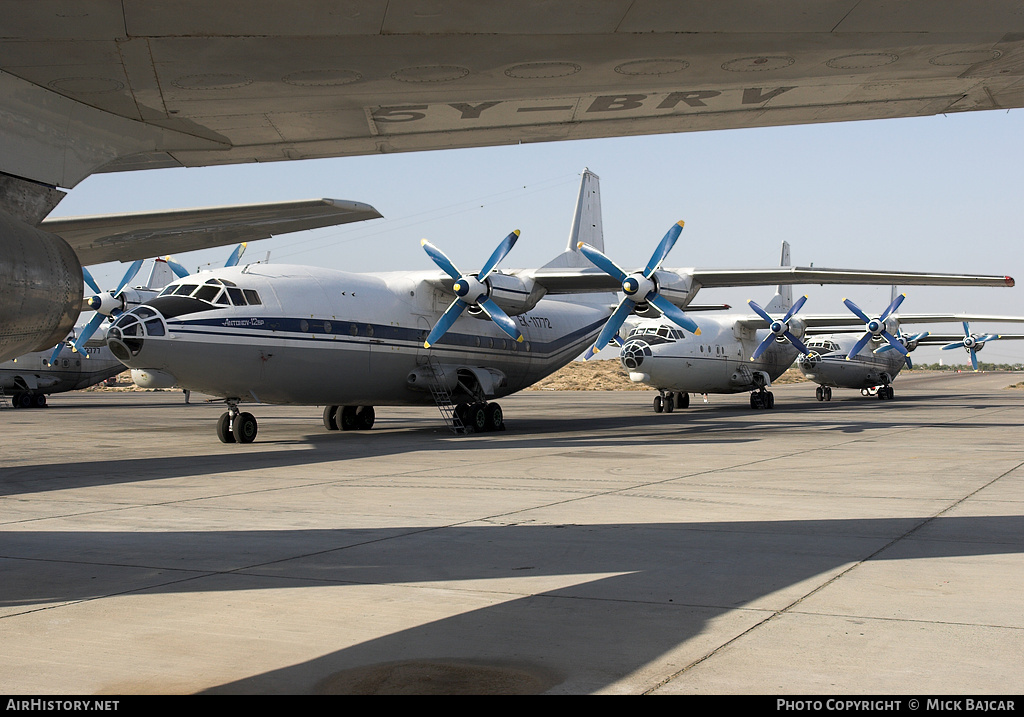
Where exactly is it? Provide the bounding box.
[54,110,1024,363]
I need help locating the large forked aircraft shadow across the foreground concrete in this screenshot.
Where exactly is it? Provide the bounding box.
[0,515,1024,693]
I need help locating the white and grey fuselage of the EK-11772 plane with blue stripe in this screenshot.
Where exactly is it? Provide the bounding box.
[108,264,610,406]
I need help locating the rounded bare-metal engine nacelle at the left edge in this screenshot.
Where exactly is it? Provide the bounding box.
[0,212,83,361]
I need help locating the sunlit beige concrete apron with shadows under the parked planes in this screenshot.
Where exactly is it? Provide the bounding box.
[0,374,1024,695]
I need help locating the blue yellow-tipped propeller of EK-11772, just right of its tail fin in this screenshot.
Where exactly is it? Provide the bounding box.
[578,221,700,355]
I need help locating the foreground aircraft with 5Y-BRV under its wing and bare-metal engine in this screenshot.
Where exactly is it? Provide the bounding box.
[0,0,1024,361]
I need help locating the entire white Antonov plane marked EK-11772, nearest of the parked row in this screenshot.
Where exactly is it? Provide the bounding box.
[106,170,1013,442]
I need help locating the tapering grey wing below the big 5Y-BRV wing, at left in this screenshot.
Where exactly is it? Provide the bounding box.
[40,199,381,266]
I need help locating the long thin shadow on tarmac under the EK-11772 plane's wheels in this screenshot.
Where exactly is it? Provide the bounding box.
[0,399,1007,497]
